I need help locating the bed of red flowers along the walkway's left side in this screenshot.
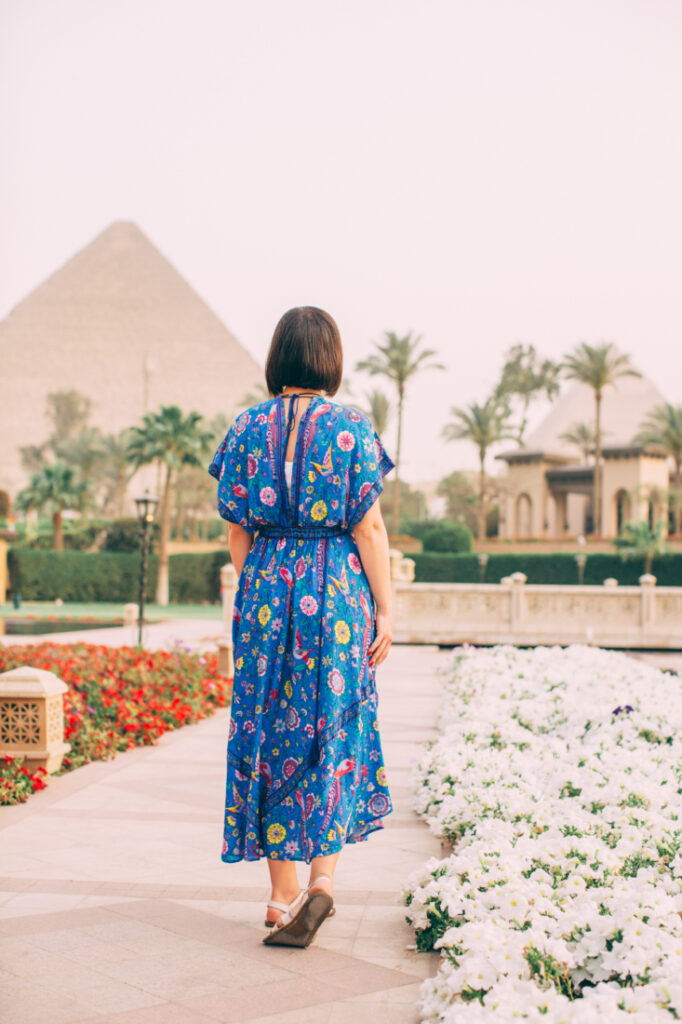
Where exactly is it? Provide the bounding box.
[0,643,232,804]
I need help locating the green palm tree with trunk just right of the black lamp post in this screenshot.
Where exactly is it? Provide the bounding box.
[128,406,214,605]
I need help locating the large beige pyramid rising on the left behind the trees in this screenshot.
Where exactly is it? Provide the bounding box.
[0,221,264,498]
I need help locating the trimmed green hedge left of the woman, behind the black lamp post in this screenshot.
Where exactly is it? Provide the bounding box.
[7,548,229,604]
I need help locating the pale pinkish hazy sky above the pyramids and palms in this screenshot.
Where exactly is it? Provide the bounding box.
[0,0,682,480]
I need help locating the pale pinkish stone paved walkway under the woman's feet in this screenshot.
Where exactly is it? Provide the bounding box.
[0,623,449,1024]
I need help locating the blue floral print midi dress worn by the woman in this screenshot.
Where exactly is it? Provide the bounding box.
[209,395,394,863]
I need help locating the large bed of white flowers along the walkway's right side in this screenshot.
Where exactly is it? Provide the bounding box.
[402,646,682,1024]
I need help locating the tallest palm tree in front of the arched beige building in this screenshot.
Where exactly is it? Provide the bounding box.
[561,341,642,537]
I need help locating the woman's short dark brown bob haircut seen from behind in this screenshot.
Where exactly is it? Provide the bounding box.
[265,306,343,397]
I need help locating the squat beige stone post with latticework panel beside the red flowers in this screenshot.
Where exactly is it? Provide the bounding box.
[0,665,71,774]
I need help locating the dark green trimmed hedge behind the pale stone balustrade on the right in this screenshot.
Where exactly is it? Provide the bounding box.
[409,551,682,587]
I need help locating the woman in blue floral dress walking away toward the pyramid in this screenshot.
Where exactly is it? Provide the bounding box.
[209,306,394,946]
